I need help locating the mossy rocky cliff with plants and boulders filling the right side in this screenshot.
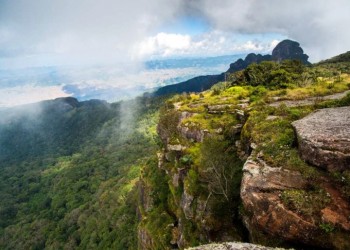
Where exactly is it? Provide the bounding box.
[139,57,350,249]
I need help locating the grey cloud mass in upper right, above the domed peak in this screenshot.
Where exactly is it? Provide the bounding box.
[182,0,350,61]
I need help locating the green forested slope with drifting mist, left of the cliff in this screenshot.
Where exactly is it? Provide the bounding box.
[0,95,161,249]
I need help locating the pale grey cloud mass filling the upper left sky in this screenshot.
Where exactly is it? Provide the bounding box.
[0,0,181,67]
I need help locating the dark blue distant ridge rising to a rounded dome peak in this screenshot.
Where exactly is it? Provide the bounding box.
[153,40,310,96]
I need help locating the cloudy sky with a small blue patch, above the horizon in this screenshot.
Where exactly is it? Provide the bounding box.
[0,0,350,106]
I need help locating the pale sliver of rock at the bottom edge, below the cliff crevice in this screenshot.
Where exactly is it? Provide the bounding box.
[188,242,283,250]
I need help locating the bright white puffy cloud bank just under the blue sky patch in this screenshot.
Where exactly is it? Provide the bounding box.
[134,30,280,58]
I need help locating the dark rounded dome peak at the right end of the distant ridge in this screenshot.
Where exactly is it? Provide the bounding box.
[272,40,309,64]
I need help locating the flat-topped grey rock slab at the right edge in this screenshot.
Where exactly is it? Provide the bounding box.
[292,107,350,171]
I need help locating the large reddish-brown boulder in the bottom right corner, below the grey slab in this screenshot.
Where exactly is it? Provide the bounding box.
[241,153,350,249]
